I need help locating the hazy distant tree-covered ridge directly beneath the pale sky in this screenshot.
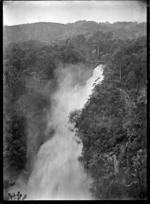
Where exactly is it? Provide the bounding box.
[3,21,146,43]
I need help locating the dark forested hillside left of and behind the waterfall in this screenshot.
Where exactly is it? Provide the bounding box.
[4,32,118,190]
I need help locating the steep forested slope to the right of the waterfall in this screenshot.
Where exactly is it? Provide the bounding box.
[70,37,147,199]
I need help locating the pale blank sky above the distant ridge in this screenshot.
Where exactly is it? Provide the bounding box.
[3,0,147,25]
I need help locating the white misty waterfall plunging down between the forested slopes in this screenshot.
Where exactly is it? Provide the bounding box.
[8,65,103,200]
